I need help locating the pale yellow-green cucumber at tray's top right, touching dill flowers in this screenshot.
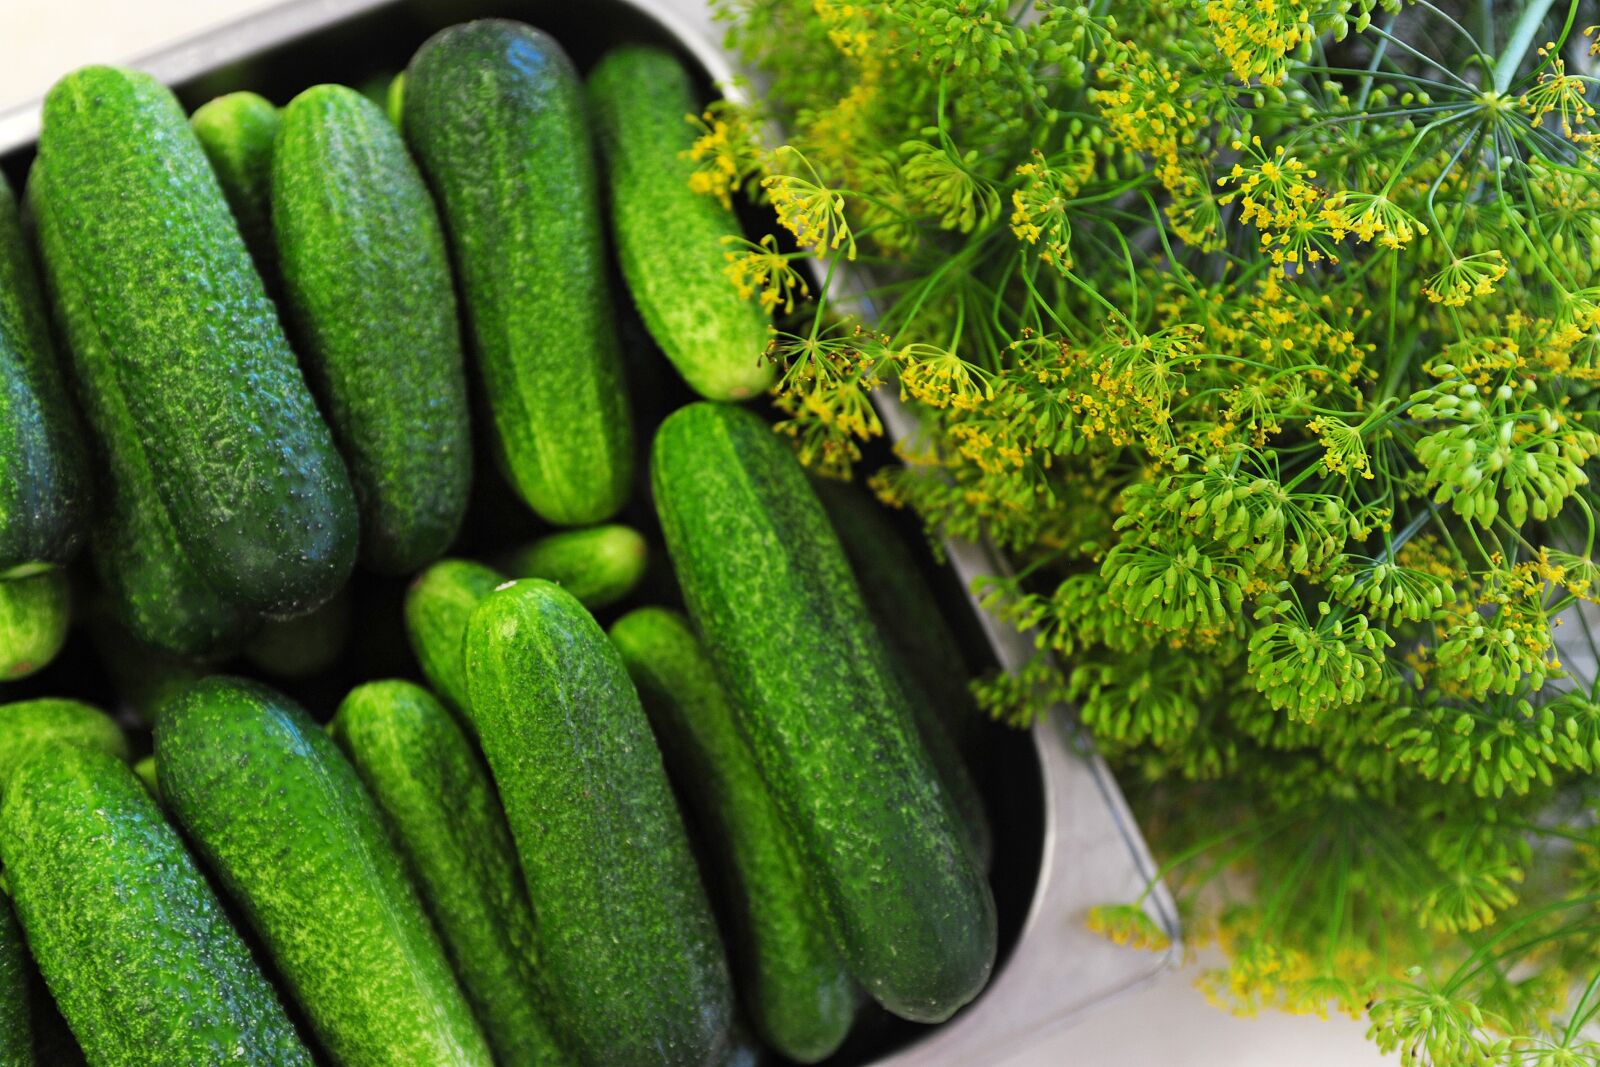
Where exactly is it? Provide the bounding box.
[589,45,776,400]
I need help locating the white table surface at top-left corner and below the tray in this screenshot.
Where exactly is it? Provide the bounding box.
[0,0,1395,1067]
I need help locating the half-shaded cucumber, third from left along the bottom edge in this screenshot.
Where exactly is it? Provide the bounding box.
[330,681,570,1067]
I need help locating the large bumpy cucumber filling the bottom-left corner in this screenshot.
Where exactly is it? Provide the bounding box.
[0,745,312,1067]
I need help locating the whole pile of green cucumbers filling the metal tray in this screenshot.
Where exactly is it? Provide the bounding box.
[0,21,997,1067]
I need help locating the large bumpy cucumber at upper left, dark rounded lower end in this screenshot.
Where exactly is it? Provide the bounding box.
[29,67,357,614]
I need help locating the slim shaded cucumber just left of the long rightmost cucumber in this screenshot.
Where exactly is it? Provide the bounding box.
[611,608,858,1064]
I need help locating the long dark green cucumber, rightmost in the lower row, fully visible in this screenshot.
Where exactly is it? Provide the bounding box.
[651,403,997,1022]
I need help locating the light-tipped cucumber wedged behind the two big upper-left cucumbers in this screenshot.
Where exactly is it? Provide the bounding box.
[189,93,278,290]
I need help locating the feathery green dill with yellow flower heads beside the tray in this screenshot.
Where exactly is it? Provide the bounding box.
[704,0,1600,1067]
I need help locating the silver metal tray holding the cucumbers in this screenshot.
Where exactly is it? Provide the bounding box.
[0,0,1181,1067]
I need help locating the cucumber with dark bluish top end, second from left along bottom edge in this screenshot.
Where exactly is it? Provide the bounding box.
[155,677,491,1067]
